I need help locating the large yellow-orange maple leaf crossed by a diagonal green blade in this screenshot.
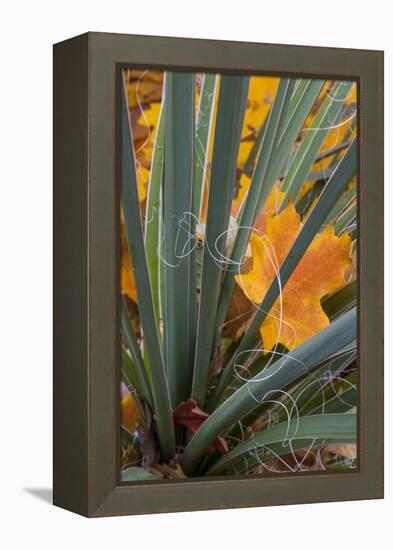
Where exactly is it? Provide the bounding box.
[235,204,351,350]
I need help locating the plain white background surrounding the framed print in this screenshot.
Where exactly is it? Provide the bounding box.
[0,0,393,550]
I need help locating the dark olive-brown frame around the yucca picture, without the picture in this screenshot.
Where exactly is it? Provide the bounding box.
[53,33,383,517]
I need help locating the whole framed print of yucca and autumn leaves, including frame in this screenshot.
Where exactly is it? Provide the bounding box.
[54,33,383,517]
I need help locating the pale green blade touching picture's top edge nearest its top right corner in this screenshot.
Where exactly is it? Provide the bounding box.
[281,82,353,204]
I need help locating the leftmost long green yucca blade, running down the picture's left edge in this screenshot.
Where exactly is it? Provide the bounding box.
[120,80,175,460]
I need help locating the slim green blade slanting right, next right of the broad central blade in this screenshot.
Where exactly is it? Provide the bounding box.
[216,78,293,344]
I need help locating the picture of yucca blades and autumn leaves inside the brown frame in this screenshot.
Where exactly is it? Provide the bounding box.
[119,71,357,481]
